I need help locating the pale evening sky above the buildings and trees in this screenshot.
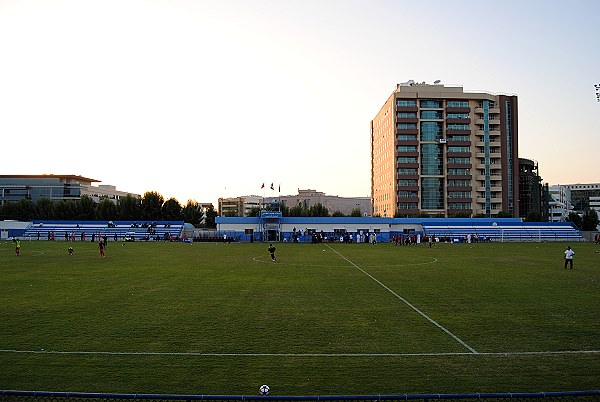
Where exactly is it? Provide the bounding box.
[0,0,600,204]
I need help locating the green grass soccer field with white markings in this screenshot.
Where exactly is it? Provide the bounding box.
[0,241,600,395]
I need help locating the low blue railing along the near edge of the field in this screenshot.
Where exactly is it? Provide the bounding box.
[0,390,600,402]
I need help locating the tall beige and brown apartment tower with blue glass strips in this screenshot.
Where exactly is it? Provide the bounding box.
[371,81,519,217]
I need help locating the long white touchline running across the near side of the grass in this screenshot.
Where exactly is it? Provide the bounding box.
[0,349,600,358]
